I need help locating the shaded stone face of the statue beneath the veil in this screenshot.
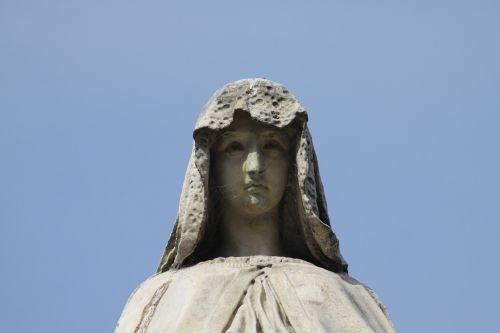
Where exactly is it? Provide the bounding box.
[213,114,290,217]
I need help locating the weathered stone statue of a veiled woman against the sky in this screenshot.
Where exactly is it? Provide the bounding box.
[115,79,394,333]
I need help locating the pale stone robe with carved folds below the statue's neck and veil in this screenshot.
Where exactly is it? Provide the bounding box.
[115,256,394,333]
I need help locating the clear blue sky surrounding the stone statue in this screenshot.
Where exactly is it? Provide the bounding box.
[0,0,500,333]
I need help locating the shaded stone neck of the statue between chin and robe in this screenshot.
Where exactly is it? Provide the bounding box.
[217,208,284,257]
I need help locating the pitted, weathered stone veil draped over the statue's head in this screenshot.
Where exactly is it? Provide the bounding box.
[157,79,347,272]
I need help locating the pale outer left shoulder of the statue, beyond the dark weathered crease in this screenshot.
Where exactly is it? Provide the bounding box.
[115,271,173,333]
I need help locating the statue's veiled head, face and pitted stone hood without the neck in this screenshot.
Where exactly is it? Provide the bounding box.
[158,79,347,272]
